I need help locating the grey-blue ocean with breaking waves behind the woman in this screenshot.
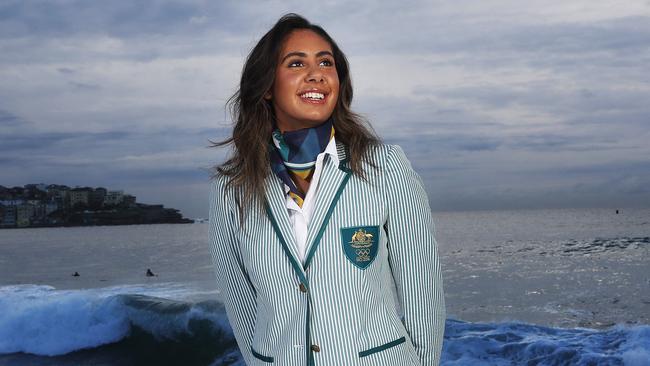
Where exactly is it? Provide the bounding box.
[0,209,650,366]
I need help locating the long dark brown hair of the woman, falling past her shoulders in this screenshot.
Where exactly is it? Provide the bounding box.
[212,13,380,218]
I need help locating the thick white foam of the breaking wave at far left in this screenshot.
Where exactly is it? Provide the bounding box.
[0,285,129,356]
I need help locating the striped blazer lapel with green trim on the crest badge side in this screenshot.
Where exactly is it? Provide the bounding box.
[304,141,352,270]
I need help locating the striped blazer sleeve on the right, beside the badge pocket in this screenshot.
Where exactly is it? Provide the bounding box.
[385,145,446,366]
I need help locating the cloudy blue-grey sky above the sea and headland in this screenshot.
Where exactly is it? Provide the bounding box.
[0,0,650,217]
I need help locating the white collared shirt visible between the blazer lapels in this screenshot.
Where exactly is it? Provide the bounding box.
[284,136,339,263]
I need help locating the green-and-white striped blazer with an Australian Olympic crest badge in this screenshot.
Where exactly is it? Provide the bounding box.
[210,142,445,366]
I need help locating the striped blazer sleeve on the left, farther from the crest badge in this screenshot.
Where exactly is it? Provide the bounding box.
[209,178,257,365]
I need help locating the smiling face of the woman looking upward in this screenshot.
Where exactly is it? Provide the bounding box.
[265,29,339,132]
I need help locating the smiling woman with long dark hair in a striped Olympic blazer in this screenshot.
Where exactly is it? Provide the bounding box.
[210,14,445,366]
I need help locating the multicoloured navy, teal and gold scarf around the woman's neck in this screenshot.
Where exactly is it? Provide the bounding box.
[269,117,334,207]
